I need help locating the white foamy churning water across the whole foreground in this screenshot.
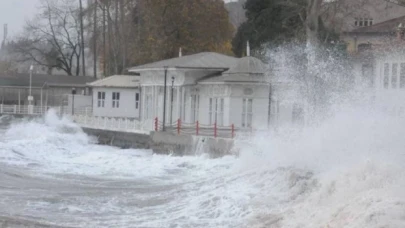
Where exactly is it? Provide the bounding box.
[0,109,405,228]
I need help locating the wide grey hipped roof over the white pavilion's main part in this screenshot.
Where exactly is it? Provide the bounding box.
[129,52,238,72]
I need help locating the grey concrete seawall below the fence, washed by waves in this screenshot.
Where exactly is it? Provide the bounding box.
[82,128,234,157]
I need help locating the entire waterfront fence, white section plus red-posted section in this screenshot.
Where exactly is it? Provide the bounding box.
[0,104,248,138]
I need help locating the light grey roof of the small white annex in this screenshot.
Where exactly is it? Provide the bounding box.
[88,75,140,88]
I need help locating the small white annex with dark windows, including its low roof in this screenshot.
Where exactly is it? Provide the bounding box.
[89,75,141,119]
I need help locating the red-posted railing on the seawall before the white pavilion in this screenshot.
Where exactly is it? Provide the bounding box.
[154,118,243,138]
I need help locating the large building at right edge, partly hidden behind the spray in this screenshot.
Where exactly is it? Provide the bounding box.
[342,3,405,114]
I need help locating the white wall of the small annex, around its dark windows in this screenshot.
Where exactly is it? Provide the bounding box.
[93,88,142,118]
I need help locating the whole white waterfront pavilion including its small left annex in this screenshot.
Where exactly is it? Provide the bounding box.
[84,52,302,129]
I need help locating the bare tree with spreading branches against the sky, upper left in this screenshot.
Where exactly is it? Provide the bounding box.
[11,0,83,75]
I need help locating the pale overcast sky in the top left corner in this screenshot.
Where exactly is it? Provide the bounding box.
[0,0,231,42]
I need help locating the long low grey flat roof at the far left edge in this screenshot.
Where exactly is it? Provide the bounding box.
[0,73,95,87]
